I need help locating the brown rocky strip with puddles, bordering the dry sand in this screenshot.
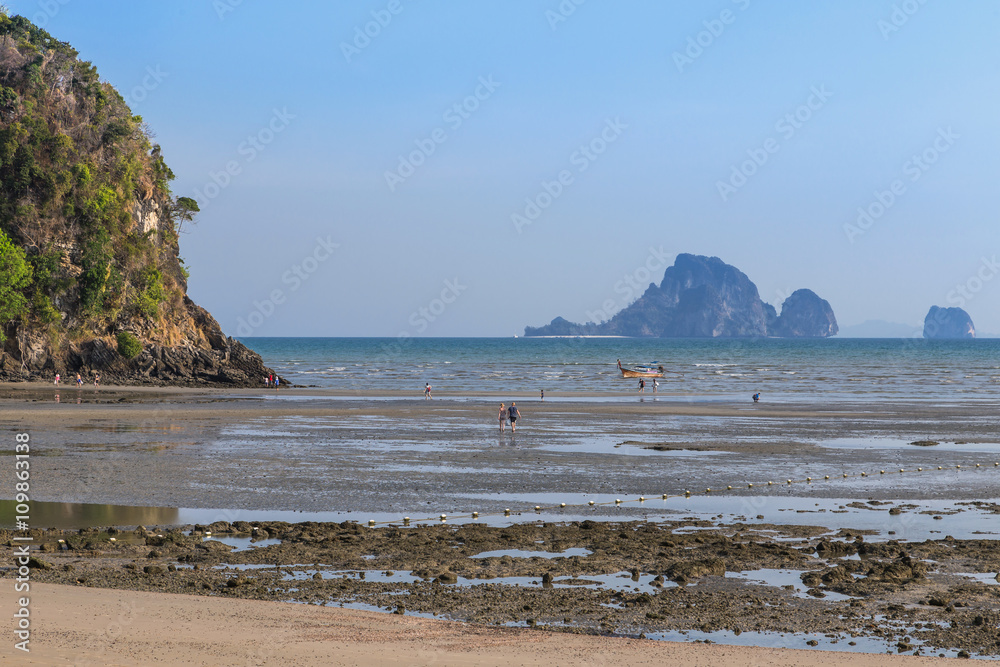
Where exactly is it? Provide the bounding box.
[7,520,1000,656]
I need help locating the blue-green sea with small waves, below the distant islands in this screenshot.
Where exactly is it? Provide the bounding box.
[241,337,1000,402]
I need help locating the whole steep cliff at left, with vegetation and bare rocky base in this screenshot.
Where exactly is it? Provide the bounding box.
[0,13,273,385]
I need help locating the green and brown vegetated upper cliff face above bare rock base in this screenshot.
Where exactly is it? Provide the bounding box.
[0,13,190,342]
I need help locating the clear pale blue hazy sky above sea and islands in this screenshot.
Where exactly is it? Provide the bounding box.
[13,0,1000,336]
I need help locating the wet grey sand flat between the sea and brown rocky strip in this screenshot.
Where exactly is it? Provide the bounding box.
[0,387,1000,518]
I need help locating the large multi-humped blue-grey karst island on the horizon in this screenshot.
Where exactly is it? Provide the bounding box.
[524,253,838,338]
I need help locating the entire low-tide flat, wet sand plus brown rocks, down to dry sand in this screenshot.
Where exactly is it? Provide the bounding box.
[0,385,1000,664]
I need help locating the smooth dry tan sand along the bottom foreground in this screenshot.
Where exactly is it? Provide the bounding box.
[0,584,945,667]
